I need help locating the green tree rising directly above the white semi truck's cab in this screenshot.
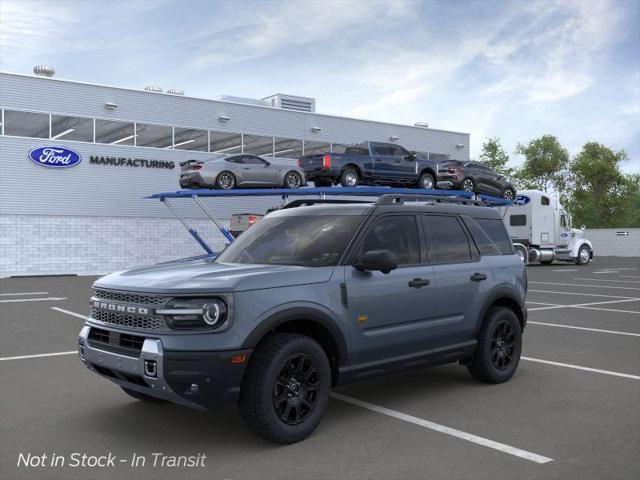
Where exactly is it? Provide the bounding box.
[516,135,569,192]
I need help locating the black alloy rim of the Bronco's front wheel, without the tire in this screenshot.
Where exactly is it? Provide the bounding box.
[272,353,320,425]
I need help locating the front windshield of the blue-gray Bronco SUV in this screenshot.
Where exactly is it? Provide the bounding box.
[216,215,363,267]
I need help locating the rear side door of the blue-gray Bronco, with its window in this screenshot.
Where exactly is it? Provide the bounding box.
[421,214,492,347]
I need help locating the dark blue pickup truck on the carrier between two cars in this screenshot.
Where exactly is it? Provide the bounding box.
[298,142,438,190]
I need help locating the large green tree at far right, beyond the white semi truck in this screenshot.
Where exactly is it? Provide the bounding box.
[565,142,640,228]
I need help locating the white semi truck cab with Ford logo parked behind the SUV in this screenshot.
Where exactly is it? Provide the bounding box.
[503,190,593,265]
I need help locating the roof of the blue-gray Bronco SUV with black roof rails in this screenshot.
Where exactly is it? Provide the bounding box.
[269,202,502,219]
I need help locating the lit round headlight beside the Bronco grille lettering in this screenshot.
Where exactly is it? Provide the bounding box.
[156,298,228,330]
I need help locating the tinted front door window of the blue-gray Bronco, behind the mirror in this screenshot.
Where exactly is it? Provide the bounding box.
[360,215,420,265]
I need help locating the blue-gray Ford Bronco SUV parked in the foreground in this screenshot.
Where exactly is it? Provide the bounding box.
[78,195,527,443]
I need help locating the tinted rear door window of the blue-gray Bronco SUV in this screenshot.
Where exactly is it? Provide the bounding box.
[422,215,471,263]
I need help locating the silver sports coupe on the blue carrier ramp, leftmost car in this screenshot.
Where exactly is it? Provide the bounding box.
[180,154,306,190]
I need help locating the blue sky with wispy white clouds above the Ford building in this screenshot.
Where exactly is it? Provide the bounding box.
[0,0,640,171]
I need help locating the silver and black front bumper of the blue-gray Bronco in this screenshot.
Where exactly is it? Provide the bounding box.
[78,325,251,410]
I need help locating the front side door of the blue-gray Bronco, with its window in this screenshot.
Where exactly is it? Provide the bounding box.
[345,214,435,365]
